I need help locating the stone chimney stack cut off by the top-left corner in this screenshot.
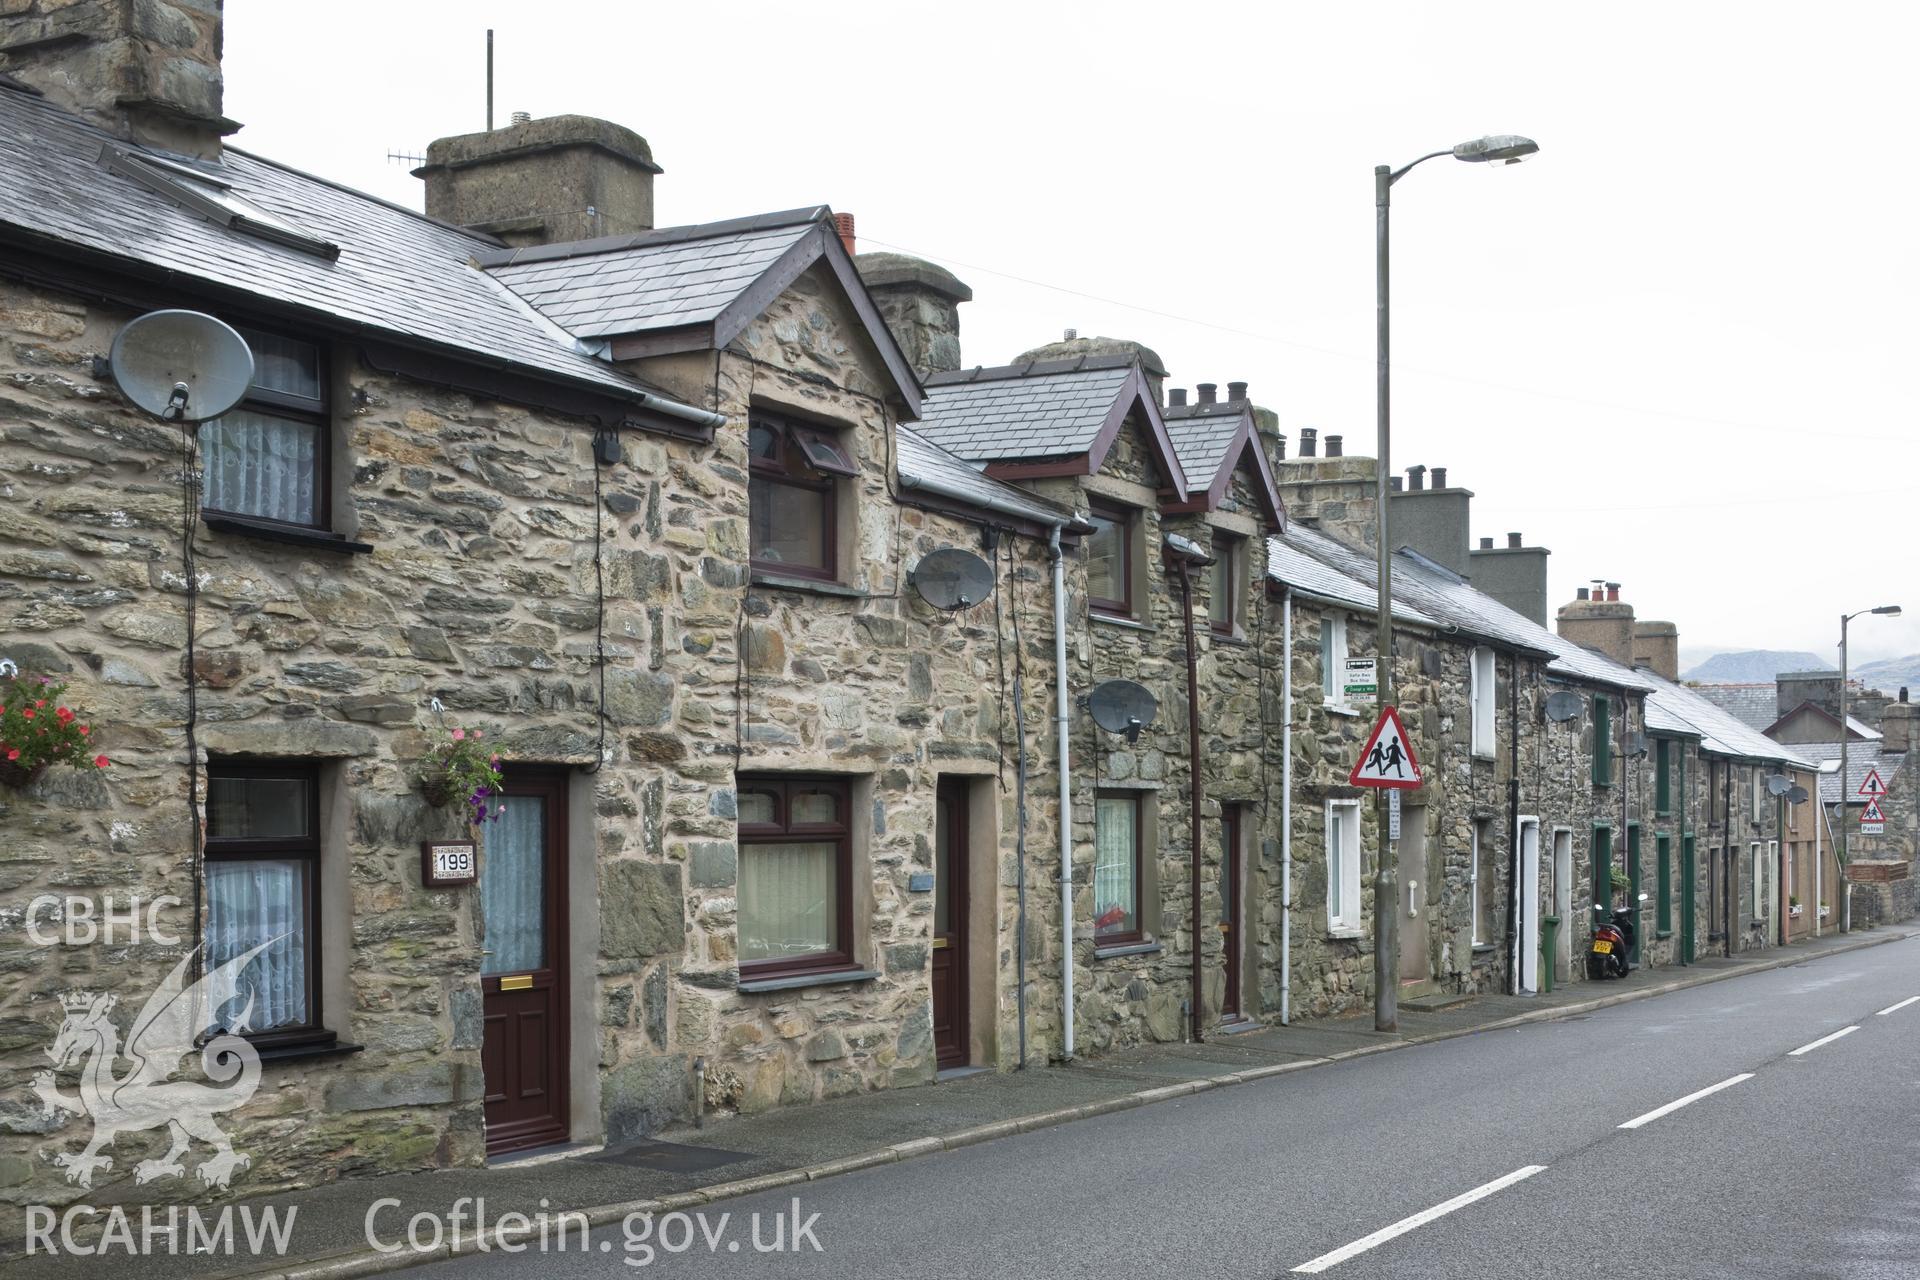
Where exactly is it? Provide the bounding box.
[0,0,240,159]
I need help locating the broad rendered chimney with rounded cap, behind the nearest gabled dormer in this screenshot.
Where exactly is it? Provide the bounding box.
[413,111,660,248]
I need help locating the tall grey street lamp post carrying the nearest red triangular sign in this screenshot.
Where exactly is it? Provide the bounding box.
[1373,134,1540,1031]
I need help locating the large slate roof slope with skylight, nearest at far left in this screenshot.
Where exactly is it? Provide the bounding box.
[0,88,668,408]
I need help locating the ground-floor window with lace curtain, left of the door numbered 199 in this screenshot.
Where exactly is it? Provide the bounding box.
[202,762,334,1048]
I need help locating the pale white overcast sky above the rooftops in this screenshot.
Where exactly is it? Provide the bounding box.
[227,0,1920,662]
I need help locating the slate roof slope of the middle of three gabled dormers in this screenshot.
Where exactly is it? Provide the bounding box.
[920,355,1135,461]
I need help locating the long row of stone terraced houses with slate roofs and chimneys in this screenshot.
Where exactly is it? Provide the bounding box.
[0,0,1889,1244]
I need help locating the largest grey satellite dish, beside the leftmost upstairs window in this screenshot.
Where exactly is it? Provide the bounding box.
[108,311,253,422]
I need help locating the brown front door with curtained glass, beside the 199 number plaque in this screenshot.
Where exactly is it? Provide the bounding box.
[480,773,568,1155]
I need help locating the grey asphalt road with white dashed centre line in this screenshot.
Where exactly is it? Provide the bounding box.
[417,938,1920,1280]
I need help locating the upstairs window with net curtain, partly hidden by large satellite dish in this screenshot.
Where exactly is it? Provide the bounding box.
[200,328,332,530]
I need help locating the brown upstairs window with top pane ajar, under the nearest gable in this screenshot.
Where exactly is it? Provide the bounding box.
[747,413,856,581]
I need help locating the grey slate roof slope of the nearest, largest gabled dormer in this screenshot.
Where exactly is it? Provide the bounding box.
[480,207,826,338]
